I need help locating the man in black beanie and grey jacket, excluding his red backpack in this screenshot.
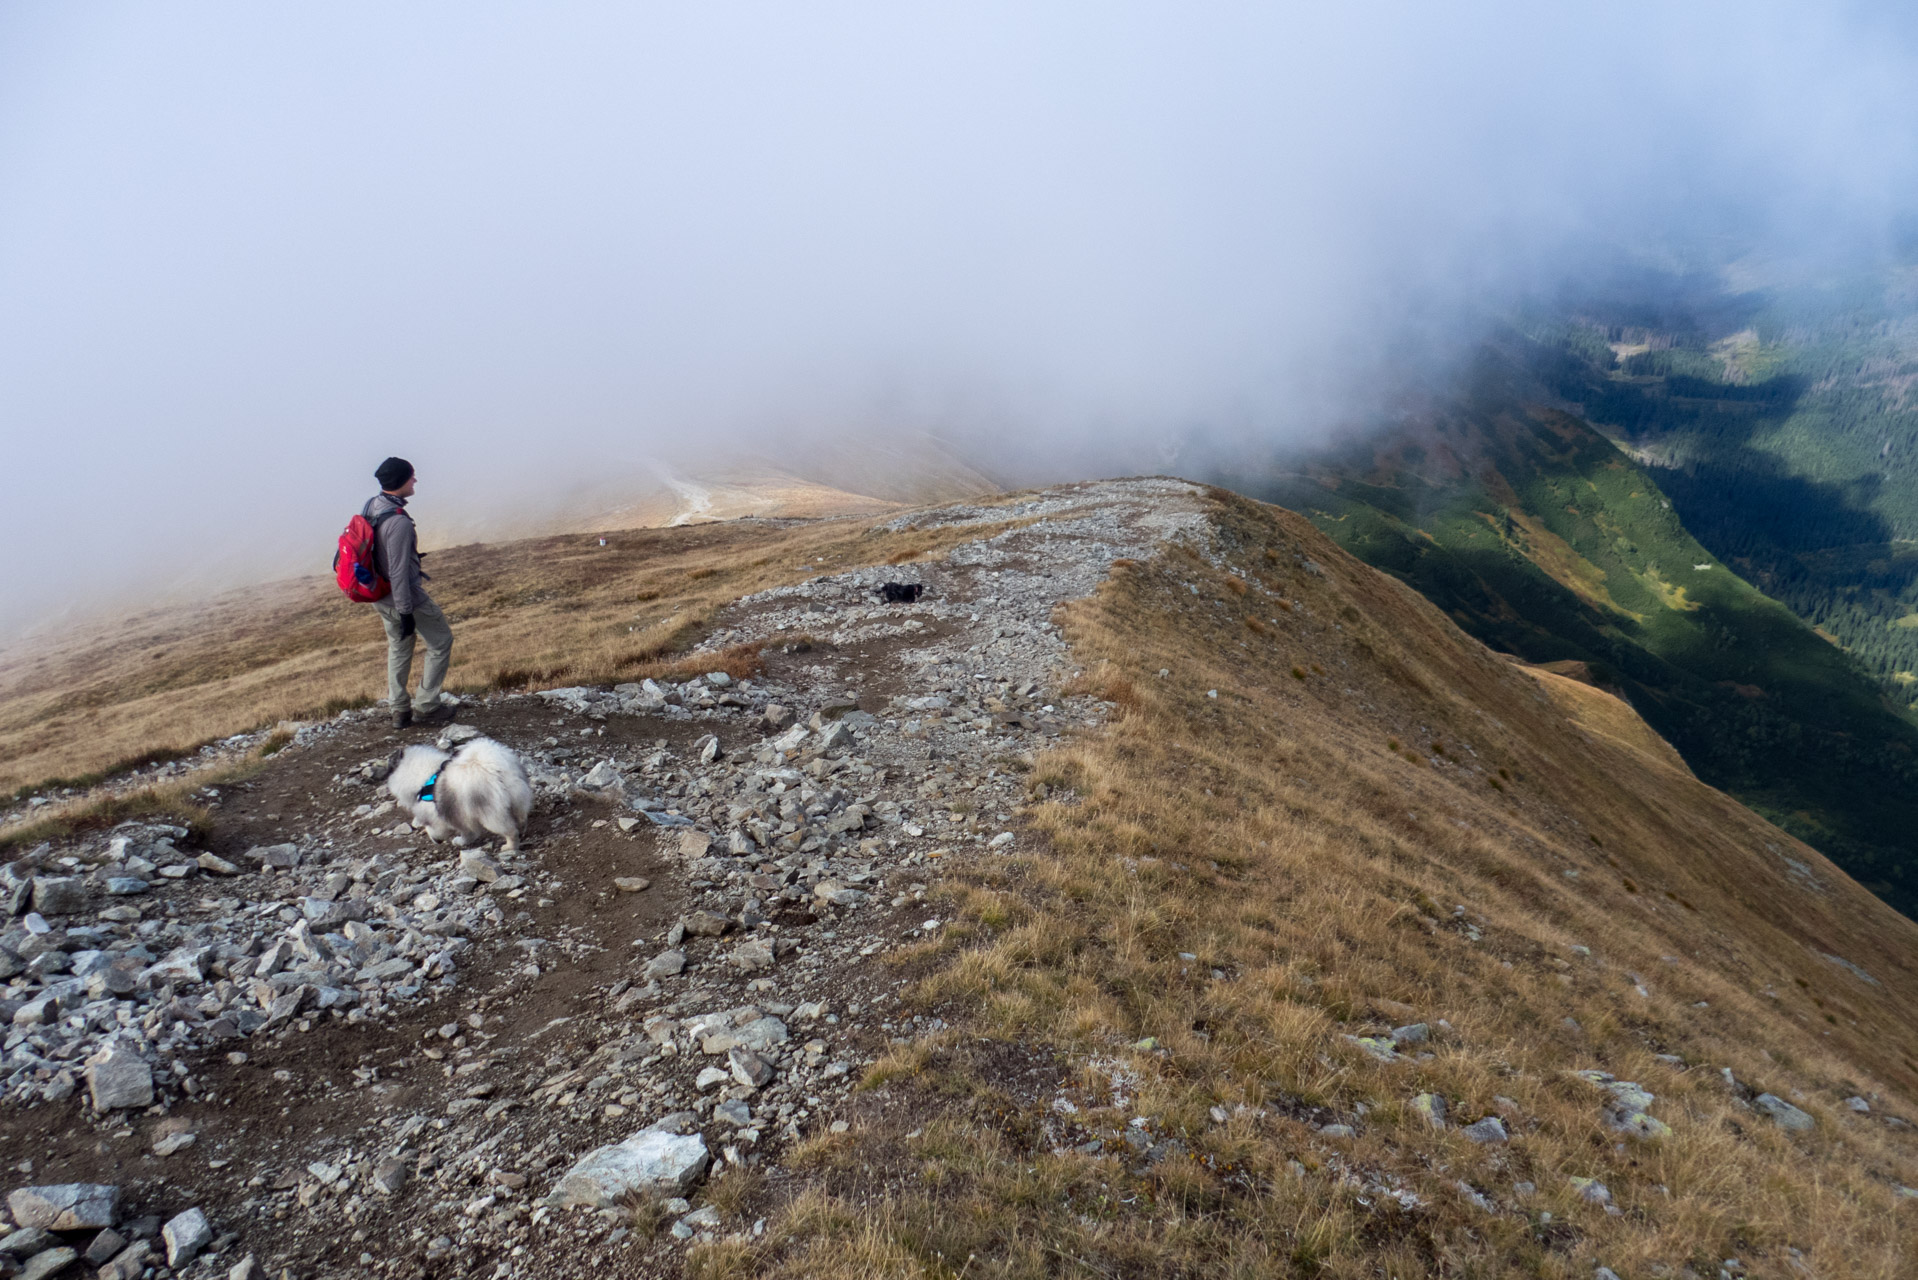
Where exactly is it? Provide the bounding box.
[361,459,453,729]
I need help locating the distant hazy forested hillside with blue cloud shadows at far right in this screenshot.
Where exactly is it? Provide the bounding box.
[1527,269,1918,702]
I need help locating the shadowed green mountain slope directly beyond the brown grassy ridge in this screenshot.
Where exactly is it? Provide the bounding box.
[1235,349,1918,913]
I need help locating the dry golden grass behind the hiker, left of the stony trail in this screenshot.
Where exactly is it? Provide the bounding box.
[0,506,1020,794]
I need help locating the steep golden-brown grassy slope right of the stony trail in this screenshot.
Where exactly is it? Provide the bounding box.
[717,495,1918,1280]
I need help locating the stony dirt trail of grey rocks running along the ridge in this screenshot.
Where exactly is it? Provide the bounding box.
[0,480,1201,1276]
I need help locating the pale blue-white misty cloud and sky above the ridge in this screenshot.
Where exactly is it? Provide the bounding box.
[0,0,1918,629]
